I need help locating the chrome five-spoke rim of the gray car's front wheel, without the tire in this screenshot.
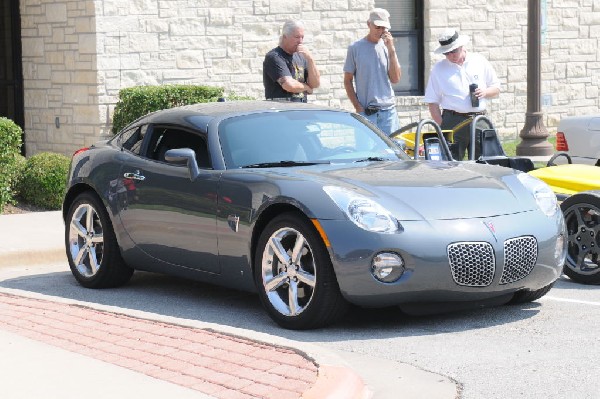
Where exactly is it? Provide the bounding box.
[261,227,316,316]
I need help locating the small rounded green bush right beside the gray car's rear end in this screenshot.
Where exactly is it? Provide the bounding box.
[17,152,71,210]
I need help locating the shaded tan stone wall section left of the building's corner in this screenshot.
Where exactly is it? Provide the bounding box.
[20,0,101,155]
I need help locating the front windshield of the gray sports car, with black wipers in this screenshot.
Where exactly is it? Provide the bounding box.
[219,110,408,168]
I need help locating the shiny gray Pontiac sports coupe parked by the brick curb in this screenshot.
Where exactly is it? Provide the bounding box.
[63,101,566,329]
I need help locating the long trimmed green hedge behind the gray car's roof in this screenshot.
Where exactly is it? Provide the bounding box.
[112,85,223,134]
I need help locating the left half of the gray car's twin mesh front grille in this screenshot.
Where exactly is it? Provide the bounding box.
[448,242,496,287]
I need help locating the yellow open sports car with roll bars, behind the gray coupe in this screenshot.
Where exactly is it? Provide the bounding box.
[390,115,600,284]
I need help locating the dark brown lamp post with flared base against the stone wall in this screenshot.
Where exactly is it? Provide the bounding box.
[517,0,554,156]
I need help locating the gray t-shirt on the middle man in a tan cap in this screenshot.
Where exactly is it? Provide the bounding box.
[344,38,396,109]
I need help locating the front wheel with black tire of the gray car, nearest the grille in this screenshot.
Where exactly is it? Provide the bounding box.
[254,213,348,330]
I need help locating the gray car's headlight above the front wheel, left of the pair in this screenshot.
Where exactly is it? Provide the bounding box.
[323,186,400,234]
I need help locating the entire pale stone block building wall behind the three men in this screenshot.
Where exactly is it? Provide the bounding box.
[21,0,600,154]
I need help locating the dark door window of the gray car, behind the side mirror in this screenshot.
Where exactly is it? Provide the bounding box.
[147,126,211,169]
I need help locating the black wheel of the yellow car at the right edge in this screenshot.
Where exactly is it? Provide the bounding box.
[561,192,600,284]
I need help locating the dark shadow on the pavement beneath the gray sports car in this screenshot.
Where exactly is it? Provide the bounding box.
[0,271,552,342]
